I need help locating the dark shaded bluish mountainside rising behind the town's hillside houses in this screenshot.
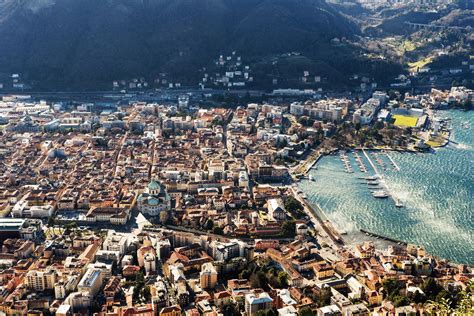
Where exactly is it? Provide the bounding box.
[0,0,359,86]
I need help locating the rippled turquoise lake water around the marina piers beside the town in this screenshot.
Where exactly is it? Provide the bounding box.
[299,110,474,264]
